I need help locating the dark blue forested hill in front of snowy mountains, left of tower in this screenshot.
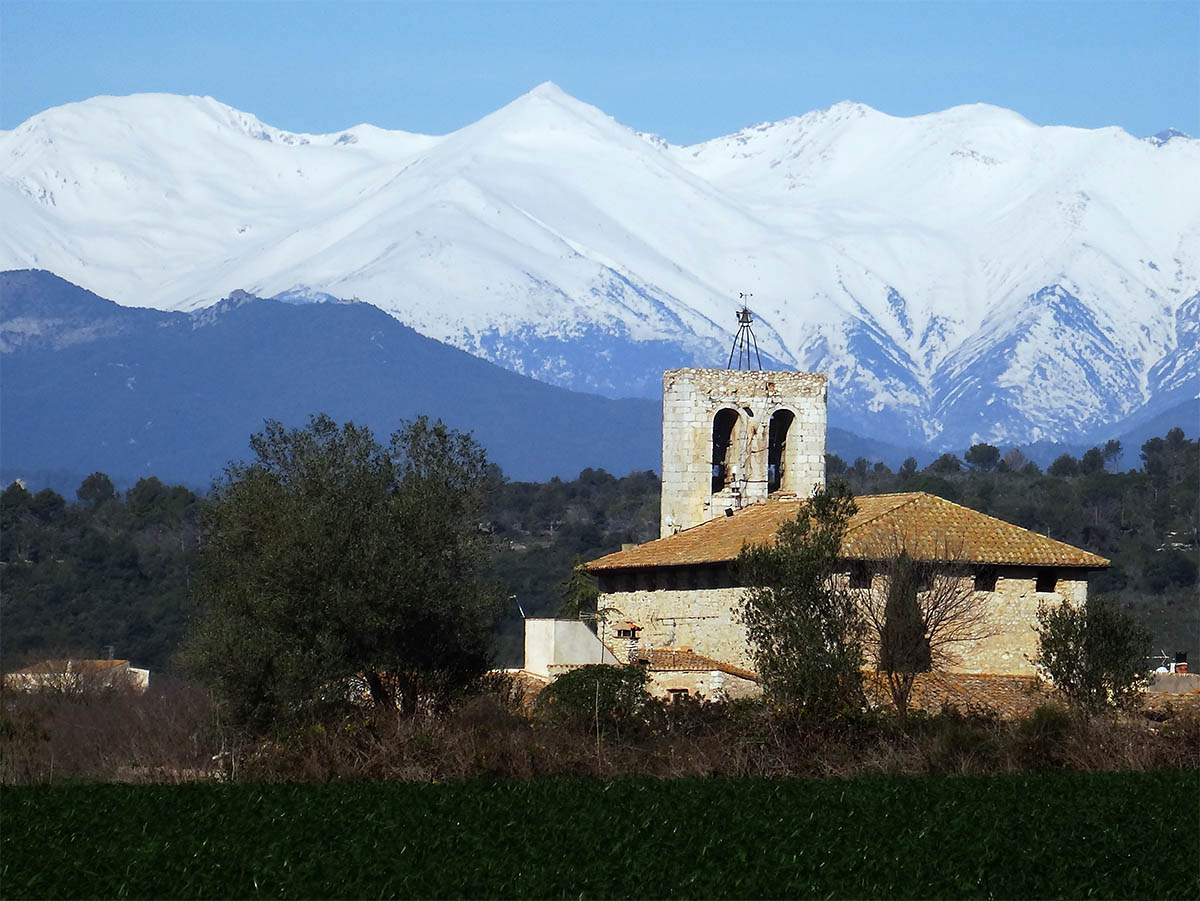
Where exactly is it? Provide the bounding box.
[0,271,660,489]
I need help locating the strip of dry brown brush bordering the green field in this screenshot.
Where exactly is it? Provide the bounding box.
[0,685,1200,785]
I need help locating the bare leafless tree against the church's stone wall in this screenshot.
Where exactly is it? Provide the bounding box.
[852,539,996,719]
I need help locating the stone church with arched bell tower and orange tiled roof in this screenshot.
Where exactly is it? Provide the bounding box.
[527,359,1109,697]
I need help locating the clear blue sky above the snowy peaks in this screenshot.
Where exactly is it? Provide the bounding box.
[0,0,1200,143]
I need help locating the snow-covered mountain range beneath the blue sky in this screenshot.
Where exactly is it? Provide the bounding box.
[0,84,1200,448]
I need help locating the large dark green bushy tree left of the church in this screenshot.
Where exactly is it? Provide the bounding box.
[185,415,504,728]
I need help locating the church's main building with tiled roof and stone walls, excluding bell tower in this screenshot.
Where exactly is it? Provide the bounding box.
[588,492,1109,674]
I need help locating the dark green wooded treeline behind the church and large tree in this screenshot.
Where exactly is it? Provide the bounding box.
[0,428,1200,669]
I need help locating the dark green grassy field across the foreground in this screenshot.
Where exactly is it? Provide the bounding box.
[0,771,1200,899]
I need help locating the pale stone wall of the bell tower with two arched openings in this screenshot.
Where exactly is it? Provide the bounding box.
[660,368,828,536]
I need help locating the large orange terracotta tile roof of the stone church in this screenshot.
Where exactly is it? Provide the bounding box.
[588,492,1109,571]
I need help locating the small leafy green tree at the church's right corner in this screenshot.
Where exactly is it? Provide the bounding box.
[1033,596,1151,714]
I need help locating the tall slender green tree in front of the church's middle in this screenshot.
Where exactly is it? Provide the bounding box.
[737,482,865,717]
